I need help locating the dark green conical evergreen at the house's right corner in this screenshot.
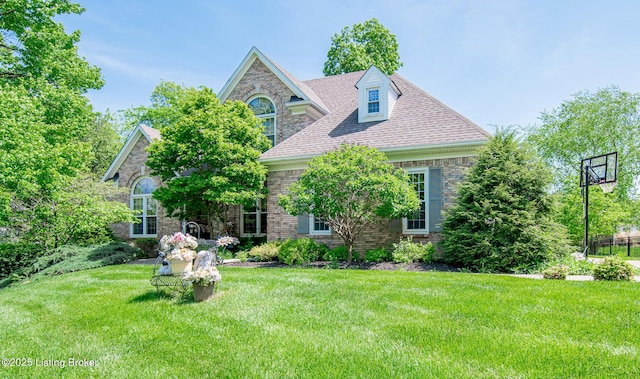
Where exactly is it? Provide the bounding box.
[443,131,570,272]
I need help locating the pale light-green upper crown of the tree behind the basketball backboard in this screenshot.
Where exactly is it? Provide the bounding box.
[527,86,640,199]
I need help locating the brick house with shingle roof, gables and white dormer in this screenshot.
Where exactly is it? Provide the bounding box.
[103,47,490,250]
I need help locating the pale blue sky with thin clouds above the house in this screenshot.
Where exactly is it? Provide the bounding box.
[57,0,640,131]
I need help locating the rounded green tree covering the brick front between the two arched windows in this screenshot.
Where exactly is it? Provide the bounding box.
[147,88,271,236]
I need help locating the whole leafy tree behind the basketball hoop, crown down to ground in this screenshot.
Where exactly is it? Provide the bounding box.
[527,86,640,242]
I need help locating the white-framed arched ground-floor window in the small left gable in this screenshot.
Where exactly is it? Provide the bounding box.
[131,178,158,237]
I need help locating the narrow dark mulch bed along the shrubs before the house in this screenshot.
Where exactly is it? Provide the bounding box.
[224,261,460,272]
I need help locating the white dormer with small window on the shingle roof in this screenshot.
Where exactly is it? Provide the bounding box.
[356,66,402,123]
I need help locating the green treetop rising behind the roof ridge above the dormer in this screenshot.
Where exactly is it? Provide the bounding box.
[322,18,402,76]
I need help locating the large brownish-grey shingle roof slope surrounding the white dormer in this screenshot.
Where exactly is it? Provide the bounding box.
[262,71,490,161]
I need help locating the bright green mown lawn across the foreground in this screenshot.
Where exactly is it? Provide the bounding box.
[0,265,640,378]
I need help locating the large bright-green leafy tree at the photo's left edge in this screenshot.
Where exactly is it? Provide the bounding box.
[0,0,129,251]
